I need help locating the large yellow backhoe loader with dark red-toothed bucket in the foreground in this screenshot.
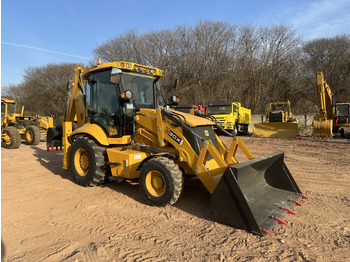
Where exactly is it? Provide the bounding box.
[47,61,306,236]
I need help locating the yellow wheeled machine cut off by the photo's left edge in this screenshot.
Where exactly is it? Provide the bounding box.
[1,98,53,149]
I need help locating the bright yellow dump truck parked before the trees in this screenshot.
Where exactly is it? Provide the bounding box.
[207,102,251,135]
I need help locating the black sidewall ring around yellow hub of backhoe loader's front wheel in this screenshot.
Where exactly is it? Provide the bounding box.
[139,158,174,206]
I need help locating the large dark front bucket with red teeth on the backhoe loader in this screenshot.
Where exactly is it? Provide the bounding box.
[211,152,302,235]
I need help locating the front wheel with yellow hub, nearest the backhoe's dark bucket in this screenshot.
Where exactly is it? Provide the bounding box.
[139,157,184,206]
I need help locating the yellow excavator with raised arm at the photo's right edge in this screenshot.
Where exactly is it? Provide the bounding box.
[313,72,350,138]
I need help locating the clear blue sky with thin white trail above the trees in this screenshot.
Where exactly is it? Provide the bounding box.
[1,0,350,86]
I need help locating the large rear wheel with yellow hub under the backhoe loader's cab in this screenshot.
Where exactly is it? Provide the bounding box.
[70,137,107,187]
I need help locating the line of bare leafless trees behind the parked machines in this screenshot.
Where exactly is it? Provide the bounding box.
[2,21,350,115]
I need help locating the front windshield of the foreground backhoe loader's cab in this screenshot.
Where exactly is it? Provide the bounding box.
[121,72,165,109]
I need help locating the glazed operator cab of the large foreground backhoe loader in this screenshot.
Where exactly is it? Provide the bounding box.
[85,64,166,137]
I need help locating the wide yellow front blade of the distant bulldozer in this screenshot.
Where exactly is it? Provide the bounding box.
[253,122,299,138]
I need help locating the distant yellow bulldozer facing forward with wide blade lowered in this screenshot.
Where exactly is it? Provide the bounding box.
[253,100,299,138]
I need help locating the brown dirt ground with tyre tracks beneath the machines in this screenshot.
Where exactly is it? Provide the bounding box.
[1,137,350,262]
